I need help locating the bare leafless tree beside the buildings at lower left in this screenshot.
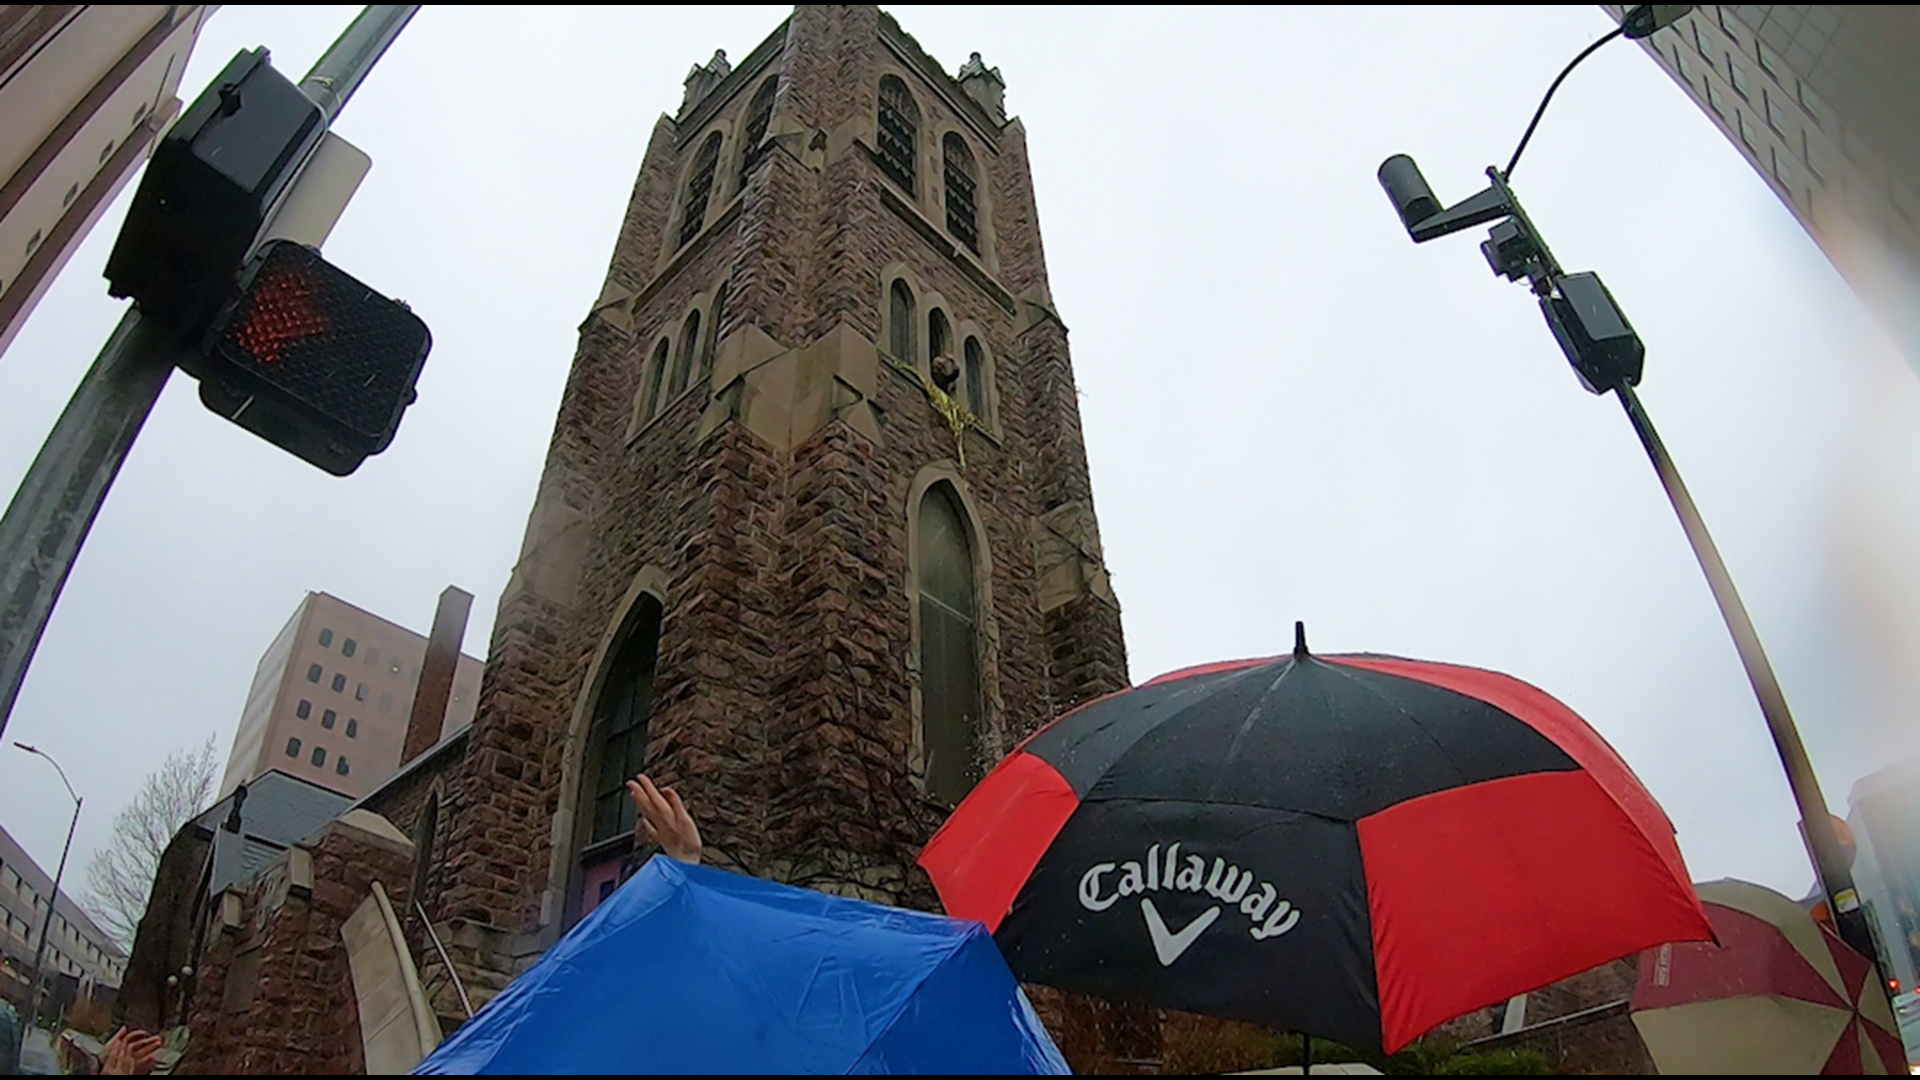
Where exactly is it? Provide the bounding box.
[86,736,219,949]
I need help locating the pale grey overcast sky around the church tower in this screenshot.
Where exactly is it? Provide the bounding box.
[0,6,1920,914]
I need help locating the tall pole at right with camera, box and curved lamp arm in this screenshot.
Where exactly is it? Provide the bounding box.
[1379,4,1885,986]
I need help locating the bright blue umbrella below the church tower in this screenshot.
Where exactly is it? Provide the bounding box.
[417,857,1068,1074]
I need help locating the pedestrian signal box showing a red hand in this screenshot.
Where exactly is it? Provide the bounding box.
[190,240,432,477]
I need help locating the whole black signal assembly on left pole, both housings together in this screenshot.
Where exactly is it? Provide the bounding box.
[108,48,432,477]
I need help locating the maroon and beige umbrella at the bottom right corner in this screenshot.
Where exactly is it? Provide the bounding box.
[1632,880,1907,1076]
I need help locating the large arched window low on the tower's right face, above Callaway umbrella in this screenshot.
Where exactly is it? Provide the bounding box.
[918,482,981,803]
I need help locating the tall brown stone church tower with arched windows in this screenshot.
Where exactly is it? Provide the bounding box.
[410,6,1127,1013]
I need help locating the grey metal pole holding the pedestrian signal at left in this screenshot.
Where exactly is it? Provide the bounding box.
[0,4,419,736]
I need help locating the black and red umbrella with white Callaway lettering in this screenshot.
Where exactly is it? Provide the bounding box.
[920,634,1713,1053]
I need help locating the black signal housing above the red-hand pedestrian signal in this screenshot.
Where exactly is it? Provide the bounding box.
[108,48,326,338]
